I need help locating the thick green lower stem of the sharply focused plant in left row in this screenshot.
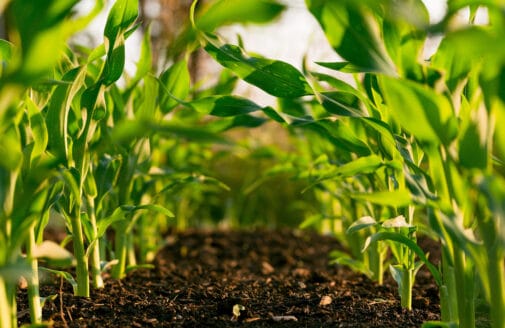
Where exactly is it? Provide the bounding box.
[70,210,89,297]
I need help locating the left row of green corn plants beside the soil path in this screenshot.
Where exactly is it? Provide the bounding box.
[0,0,296,328]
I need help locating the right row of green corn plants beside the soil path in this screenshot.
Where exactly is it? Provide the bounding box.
[194,0,505,327]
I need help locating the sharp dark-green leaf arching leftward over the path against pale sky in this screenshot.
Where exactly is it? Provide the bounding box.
[205,41,313,98]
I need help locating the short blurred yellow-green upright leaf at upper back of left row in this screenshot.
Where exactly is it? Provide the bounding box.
[159,60,191,113]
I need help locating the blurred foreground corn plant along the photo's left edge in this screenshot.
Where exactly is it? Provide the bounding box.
[0,0,91,327]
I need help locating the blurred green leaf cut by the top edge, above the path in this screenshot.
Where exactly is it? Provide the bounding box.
[196,0,285,32]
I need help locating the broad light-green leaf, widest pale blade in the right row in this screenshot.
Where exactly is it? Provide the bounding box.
[380,76,457,144]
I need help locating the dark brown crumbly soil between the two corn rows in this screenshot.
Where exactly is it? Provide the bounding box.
[18,230,440,327]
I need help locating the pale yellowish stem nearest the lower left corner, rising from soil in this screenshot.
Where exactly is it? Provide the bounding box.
[26,226,42,325]
